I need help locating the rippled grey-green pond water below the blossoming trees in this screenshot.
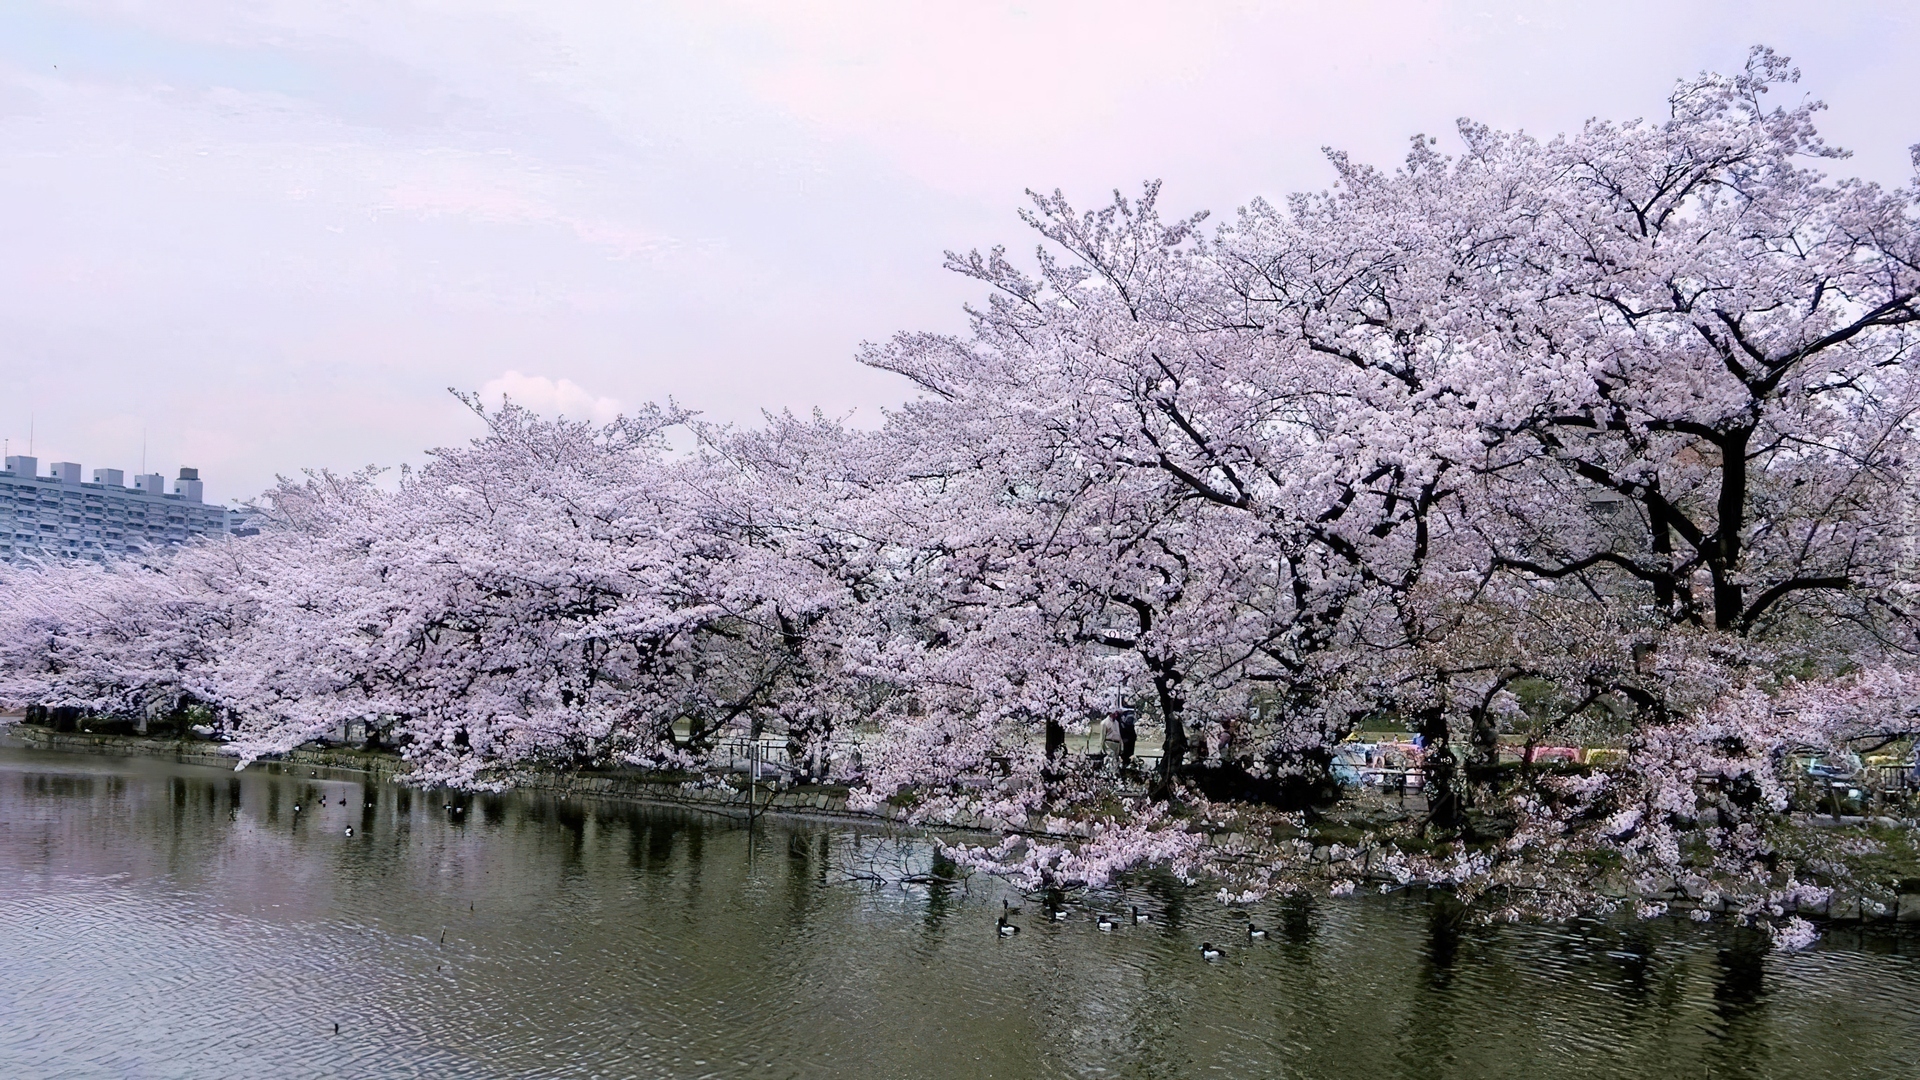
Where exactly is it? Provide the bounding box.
[0,748,1920,1078]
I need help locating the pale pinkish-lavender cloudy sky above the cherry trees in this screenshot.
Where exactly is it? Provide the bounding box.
[0,0,1920,502]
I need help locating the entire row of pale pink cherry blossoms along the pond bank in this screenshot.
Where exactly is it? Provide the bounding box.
[0,50,1920,940]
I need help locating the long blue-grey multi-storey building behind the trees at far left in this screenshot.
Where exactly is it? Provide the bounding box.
[0,455,232,561]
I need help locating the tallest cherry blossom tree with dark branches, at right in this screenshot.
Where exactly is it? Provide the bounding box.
[868,50,1920,907]
